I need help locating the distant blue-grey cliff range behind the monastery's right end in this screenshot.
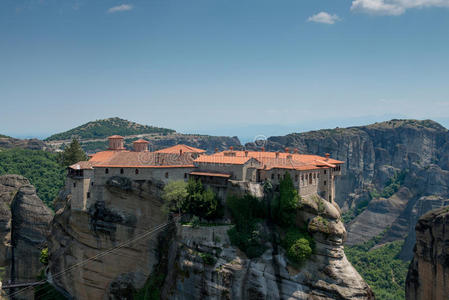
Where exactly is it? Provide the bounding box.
[247,120,449,253]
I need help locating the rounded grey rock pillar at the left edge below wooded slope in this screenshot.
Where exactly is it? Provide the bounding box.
[0,175,52,283]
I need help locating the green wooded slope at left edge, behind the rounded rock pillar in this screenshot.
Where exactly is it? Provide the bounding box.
[0,149,65,207]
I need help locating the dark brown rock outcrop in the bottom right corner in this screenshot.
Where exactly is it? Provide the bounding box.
[406,208,449,300]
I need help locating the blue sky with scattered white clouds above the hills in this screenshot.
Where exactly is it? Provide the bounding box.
[0,0,449,139]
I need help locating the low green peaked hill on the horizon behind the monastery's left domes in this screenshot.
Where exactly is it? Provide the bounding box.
[45,118,175,141]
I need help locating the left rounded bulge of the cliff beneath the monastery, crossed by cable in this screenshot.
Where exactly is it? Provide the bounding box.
[49,181,166,299]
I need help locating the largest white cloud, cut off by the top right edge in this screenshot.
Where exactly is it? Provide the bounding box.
[351,0,449,16]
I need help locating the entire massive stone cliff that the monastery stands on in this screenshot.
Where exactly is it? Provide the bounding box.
[49,178,374,299]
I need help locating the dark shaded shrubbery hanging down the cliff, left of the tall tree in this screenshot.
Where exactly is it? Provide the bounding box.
[226,194,266,258]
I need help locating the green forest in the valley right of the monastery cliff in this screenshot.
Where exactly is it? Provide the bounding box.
[345,234,409,300]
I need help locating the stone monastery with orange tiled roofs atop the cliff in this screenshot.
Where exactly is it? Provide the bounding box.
[66,135,343,210]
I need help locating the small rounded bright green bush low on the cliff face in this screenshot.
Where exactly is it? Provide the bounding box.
[281,227,314,265]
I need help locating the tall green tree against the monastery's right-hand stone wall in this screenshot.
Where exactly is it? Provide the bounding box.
[272,172,299,227]
